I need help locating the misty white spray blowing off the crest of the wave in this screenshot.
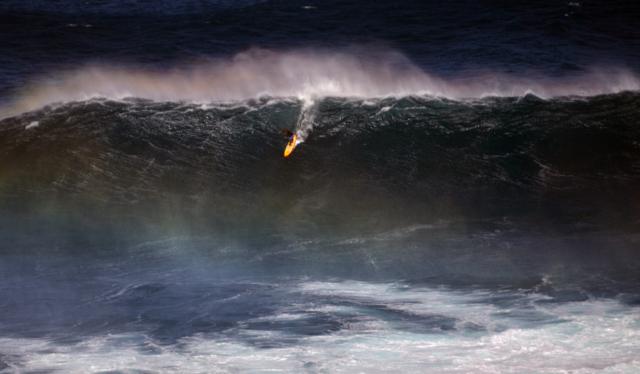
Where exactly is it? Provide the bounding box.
[0,49,640,117]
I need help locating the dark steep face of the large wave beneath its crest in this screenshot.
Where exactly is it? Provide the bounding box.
[0,93,640,238]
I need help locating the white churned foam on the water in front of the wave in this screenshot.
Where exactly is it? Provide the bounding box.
[0,282,640,373]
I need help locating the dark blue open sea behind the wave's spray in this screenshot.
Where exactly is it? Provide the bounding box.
[0,0,640,90]
